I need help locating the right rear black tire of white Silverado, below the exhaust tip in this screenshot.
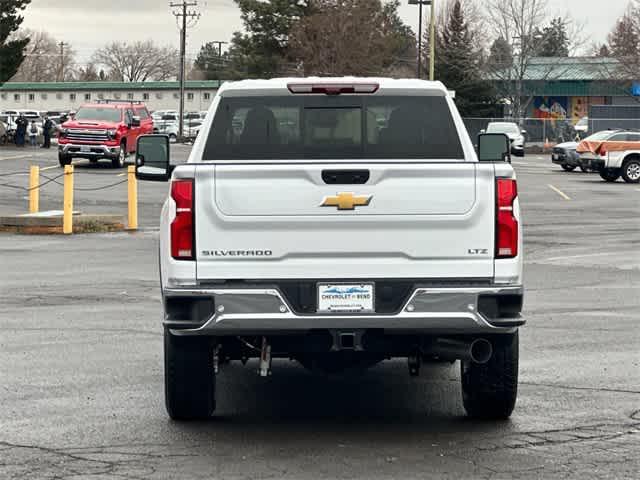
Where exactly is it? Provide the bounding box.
[461,332,518,419]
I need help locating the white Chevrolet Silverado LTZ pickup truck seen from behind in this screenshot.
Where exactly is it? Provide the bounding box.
[136,78,524,419]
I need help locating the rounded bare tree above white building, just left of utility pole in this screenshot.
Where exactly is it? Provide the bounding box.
[92,40,179,82]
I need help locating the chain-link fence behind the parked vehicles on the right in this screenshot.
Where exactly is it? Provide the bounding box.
[463,118,640,147]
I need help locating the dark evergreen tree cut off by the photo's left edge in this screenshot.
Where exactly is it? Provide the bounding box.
[0,0,31,85]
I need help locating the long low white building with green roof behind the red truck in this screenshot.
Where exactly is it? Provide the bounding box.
[0,80,220,111]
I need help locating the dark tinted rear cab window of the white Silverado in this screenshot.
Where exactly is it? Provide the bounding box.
[203,94,464,161]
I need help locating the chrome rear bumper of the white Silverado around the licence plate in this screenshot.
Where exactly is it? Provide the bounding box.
[163,286,524,335]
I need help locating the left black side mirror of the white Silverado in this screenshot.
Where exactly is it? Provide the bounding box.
[136,135,173,182]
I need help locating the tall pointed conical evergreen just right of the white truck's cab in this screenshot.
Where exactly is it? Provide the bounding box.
[435,0,495,116]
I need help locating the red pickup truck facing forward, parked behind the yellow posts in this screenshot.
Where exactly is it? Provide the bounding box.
[58,100,153,168]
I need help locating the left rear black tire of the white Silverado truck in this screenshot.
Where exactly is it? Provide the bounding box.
[164,329,216,420]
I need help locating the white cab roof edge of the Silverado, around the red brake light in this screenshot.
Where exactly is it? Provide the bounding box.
[219,77,447,95]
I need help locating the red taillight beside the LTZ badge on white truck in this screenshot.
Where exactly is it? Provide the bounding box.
[496,178,518,258]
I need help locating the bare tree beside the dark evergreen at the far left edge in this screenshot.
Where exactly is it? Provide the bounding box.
[11,30,75,82]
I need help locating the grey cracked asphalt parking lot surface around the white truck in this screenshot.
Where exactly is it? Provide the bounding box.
[0,146,640,480]
